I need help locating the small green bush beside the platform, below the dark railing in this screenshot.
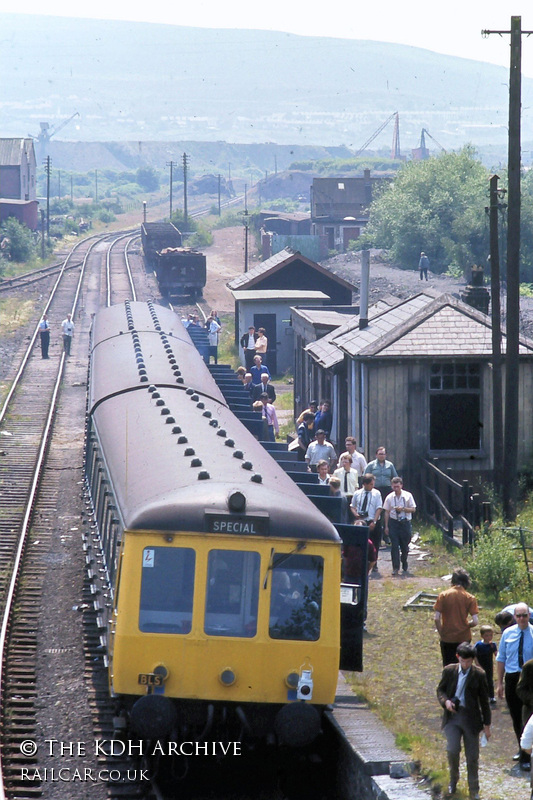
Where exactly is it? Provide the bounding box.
[465,528,527,603]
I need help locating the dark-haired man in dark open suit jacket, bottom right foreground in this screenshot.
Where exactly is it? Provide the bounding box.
[437,642,491,800]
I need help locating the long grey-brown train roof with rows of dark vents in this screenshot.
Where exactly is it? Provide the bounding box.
[88,302,340,542]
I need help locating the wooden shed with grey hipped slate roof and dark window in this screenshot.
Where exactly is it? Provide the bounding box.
[295,290,533,481]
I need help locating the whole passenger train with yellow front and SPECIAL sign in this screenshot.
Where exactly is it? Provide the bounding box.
[86,303,340,746]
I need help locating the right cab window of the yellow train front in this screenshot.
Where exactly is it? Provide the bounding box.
[269,553,324,642]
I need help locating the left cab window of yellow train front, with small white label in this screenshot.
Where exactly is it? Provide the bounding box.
[139,547,195,633]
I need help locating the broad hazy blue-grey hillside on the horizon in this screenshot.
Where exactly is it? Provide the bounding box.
[0,14,533,150]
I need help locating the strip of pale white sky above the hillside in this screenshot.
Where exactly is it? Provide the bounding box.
[13,0,533,78]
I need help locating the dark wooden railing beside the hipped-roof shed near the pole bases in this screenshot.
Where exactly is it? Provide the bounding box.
[420,458,491,547]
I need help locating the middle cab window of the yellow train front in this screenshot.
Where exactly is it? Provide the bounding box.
[204,550,260,638]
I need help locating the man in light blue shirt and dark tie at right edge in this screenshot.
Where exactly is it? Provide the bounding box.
[496,603,533,770]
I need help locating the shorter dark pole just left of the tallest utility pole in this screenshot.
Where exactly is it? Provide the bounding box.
[487,175,505,494]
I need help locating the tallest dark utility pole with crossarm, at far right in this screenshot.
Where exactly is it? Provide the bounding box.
[482,17,533,522]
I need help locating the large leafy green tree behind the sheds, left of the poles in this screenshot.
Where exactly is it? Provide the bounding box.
[358,147,489,272]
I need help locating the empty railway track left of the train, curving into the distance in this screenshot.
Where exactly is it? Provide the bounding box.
[0,234,155,798]
